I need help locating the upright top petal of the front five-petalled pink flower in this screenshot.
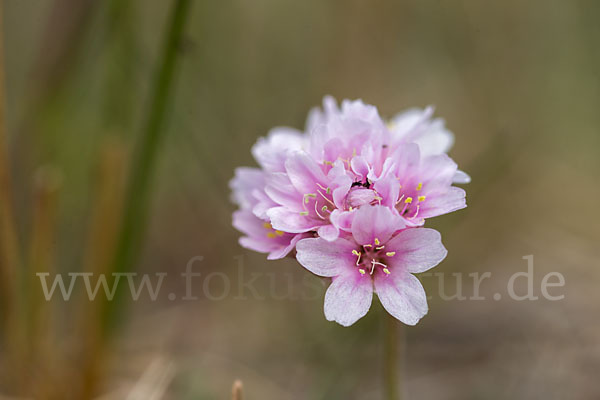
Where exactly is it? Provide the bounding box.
[352,205,404,245]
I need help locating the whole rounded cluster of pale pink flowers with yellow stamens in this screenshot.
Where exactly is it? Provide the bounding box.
[230,97,470,326]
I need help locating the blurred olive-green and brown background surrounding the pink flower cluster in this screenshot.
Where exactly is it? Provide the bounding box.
[0,0,600,399]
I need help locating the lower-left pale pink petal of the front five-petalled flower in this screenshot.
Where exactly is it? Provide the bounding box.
[324,274,373,326]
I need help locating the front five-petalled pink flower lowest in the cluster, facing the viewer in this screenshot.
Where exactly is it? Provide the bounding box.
[296,205,447,326]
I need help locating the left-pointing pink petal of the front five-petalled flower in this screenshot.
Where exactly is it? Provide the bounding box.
[296,238,357,277]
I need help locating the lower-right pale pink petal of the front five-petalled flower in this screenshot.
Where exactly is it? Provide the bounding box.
[375,271,428,325]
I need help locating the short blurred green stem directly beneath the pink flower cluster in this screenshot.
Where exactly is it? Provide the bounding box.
[384,313,405,400]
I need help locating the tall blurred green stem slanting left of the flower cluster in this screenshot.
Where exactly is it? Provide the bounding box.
[105,0,191,325]
